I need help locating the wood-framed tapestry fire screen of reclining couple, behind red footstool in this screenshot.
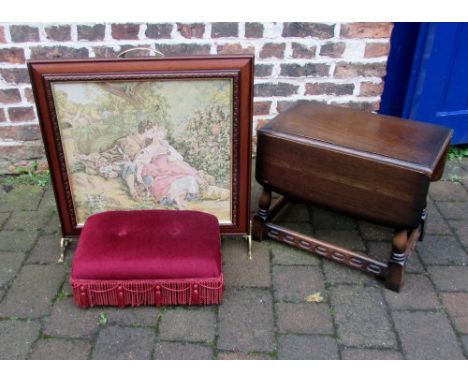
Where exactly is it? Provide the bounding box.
[28,56,253,237]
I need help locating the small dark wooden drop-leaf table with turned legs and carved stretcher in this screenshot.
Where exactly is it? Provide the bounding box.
[252,101,452,291]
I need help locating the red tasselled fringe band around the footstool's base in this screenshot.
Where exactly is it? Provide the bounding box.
[70,273,224,308]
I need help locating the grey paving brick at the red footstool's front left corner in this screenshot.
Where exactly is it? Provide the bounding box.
[43,298,103,338]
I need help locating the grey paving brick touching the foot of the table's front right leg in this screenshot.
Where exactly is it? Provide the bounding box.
[384,274,440,310]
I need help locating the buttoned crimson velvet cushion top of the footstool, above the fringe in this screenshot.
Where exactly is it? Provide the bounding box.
[71,211,221,280]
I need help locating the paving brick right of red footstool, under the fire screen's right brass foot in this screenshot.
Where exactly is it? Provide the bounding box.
[222,238,271,287]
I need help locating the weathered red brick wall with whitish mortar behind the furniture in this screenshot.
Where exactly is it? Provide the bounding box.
[0,22,393,173]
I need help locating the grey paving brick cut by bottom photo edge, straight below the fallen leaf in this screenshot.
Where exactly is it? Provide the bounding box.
[278,334,339,360]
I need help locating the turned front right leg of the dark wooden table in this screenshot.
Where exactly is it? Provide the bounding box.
[385,230,408,292]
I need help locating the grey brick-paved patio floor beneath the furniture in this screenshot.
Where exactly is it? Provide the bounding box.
[0,159,468,359]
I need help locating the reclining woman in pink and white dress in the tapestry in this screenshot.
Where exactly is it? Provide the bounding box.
[135,126,201,209]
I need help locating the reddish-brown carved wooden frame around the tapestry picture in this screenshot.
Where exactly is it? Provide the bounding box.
[28,55,254,238]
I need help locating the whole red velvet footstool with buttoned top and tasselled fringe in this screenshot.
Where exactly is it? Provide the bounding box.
[70,210,224,308]
